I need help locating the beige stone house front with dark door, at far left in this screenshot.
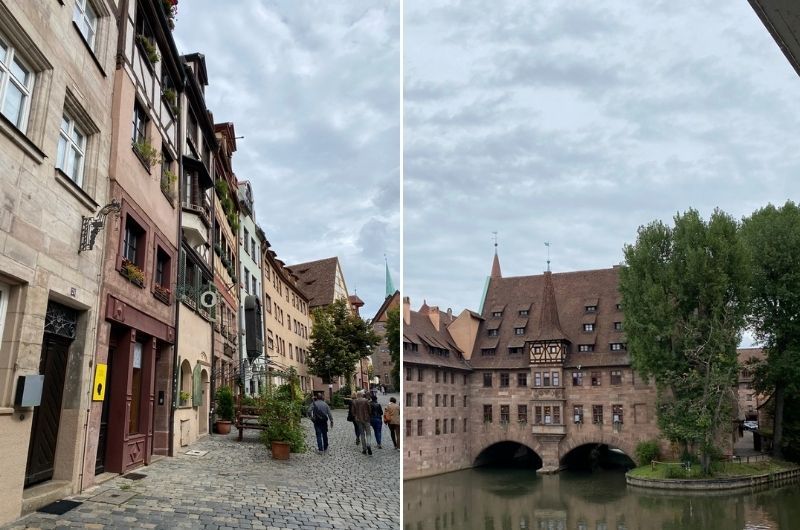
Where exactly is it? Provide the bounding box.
[0,0,117,525]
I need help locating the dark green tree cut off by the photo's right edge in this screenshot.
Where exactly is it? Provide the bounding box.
[741,201,800,458]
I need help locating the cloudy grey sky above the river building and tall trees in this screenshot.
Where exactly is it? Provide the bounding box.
[404,0,800,334]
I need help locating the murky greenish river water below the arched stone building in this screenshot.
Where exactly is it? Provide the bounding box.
[403,467,800,530]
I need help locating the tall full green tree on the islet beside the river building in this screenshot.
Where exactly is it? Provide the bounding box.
[620,210,748,474]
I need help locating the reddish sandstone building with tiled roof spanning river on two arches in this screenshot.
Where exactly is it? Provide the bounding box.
[403,256,669,478]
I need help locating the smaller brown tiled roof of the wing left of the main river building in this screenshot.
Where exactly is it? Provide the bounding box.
[403,304,470,370]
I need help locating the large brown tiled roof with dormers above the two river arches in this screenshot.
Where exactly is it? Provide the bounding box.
[470,268,630,369]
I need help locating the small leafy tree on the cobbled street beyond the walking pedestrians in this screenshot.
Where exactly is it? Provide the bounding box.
[307,299,380,388]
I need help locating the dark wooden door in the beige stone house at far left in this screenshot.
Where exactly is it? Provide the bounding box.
[25,333,71,487]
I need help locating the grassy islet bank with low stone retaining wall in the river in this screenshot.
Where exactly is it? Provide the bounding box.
[625,460,800,490]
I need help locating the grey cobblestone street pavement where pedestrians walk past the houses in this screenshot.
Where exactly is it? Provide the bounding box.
[4,390,400,529]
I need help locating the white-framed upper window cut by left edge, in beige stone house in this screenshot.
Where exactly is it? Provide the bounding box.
[0,37,34,132]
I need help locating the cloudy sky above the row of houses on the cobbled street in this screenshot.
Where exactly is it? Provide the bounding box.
[174,0,400,318]
